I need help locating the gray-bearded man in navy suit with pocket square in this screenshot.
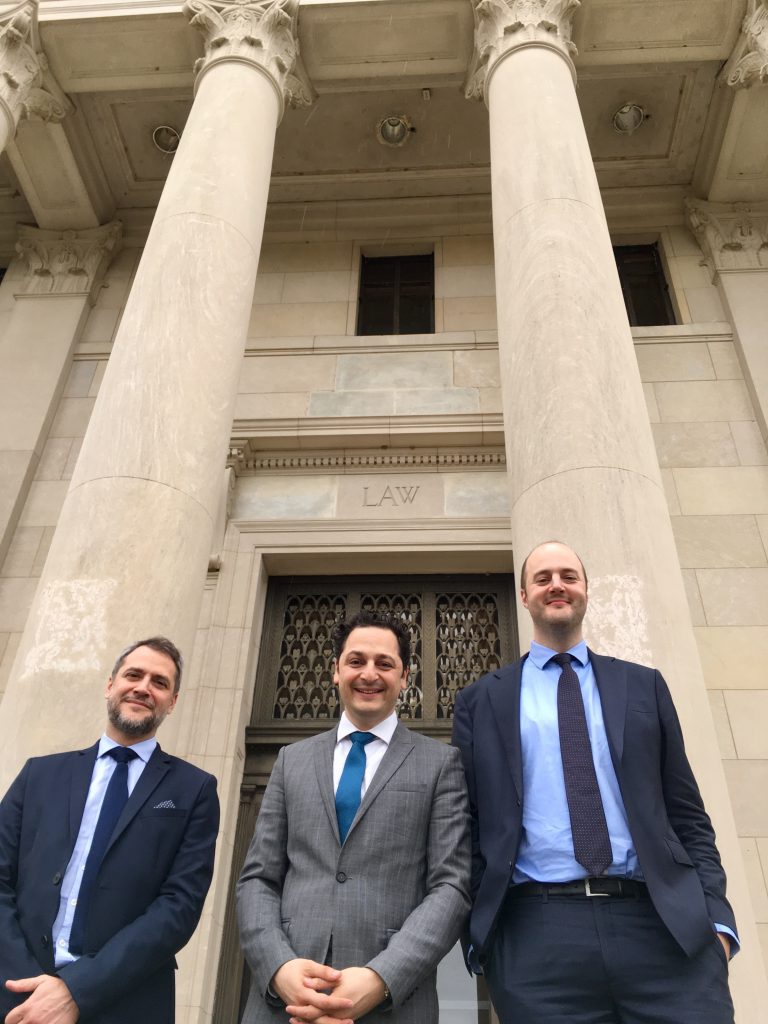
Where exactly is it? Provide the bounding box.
[0,637,219,1024]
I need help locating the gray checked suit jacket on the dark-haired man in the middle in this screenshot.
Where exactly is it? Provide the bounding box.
[238,725,470,1024]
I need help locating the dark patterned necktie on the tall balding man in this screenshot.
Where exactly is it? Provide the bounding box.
[551,654,613,876]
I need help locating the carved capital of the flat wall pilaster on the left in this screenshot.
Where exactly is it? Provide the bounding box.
[16,221,123,295]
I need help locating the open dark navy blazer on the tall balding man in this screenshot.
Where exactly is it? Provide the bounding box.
[454,651,736,966]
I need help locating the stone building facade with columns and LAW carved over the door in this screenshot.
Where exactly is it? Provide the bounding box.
[0,0,768,1024]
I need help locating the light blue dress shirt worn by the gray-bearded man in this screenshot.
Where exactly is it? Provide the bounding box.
[52,735,158,968]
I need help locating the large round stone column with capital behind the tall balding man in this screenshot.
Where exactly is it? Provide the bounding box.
[467,0,768,1007]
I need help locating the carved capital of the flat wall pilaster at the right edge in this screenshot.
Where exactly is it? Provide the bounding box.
[685,199,768,271]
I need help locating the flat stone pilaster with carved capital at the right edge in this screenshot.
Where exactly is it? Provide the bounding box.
[685,208,768,442]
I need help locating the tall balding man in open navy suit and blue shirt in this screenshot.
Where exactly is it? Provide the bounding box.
[454,541,738,1024]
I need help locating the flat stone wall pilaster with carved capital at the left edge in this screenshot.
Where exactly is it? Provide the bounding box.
[0,223,121,563]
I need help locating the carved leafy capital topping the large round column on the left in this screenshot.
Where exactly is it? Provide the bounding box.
[184,0,315,106]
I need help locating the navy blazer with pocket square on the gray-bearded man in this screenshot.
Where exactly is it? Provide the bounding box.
[0,744,219,1024]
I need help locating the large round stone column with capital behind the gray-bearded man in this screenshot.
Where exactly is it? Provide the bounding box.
[0,0,311,788]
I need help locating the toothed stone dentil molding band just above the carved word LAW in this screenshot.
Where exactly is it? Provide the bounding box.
[226,440,506,475]
